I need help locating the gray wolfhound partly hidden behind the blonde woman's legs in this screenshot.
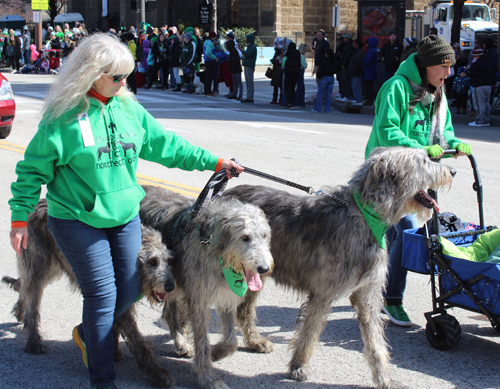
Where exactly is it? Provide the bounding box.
[2,200,175,387]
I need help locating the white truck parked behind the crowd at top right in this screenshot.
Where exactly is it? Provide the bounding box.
[424,0,498,51]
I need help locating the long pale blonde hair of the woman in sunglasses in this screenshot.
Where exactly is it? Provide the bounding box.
[42,33,135,121]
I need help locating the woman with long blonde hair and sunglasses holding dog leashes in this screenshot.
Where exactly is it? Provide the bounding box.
[9,34,242,388]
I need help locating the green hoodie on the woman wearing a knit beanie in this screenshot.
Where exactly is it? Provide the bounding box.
[365,54,461,158]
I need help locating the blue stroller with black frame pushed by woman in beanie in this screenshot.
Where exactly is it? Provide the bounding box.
[403,150,500,350]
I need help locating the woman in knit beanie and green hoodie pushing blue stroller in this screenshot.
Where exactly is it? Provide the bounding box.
[365,35,471,326]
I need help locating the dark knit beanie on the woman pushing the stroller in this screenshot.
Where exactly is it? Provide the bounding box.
[417,35,455,68]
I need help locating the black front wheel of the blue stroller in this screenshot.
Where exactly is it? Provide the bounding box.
[425,314,462,350]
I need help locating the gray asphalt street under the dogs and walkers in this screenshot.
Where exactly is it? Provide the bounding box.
[0,73,500,389]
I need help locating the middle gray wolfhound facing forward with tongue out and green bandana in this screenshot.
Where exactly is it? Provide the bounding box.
[141,187,273,389]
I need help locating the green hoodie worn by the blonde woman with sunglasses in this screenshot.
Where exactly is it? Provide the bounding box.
[9,97,217,228]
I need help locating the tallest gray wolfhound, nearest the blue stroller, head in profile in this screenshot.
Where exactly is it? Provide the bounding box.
[224,147,454,388]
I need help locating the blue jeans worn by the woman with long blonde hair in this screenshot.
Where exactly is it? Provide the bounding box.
[47,215,141,387]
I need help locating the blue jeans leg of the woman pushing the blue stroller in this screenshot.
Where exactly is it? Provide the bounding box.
[384,215,418,305]
